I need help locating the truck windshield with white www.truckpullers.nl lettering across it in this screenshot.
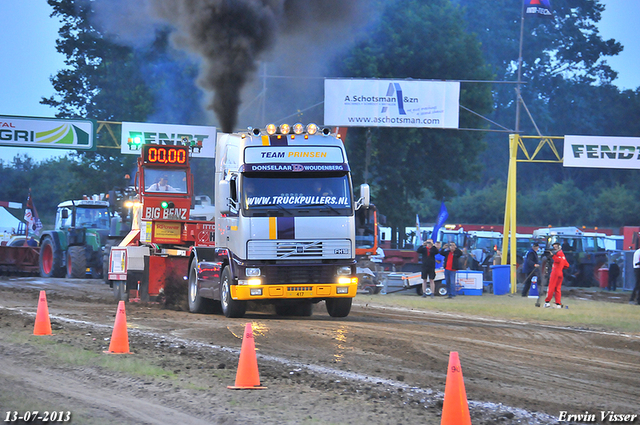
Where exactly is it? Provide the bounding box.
[241,174,351,215]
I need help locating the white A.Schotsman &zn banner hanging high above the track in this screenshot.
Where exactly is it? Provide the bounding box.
[324,79,460,128]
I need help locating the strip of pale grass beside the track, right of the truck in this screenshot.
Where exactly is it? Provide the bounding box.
[354,292,640,334]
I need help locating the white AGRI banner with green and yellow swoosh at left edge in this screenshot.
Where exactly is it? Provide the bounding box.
[0,115,96,151]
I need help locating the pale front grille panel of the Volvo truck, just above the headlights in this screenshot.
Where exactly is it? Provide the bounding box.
[247,239,351,260]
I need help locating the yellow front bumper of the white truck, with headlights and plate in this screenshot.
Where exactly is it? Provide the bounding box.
[230,281,358,300]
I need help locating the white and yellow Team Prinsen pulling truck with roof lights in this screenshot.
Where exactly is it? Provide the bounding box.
[187,124,362,317]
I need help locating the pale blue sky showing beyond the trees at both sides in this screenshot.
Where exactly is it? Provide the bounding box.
[0,0,640,163]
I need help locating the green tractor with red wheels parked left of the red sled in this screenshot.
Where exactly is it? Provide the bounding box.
[40,200,111,279]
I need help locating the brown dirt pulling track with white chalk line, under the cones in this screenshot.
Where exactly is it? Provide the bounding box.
[0,278,640,424]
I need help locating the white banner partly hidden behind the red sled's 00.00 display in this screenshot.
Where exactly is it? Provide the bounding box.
[120,122,216,158]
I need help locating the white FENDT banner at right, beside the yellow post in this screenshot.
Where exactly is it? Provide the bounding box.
[563,136,640,169]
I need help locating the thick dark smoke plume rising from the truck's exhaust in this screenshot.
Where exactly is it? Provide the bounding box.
[151,0,366,132]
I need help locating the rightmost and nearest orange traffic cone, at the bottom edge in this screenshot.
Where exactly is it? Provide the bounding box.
[440,351,471,425]
